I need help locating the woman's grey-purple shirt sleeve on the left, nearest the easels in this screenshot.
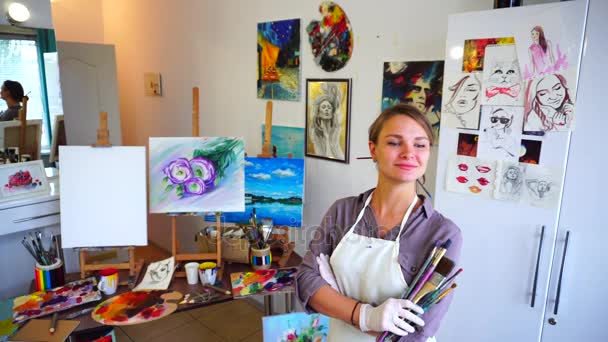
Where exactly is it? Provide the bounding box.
[296,203,337,313]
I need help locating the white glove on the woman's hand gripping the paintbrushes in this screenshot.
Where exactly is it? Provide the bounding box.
[359,298,424,336]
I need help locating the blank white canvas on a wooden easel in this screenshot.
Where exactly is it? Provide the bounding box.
[59,146,148,248]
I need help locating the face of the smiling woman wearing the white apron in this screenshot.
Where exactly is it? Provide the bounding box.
[369,115,430,183]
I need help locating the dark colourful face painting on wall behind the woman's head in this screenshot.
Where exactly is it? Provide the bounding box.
[382,61,443,136]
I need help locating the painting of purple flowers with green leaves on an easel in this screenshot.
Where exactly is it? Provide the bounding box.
[149,137,245,213]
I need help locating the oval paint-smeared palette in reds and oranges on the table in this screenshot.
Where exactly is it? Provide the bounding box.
[91,291,182,325]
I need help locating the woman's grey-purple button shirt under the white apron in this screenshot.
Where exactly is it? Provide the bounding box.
[296,189,462,342]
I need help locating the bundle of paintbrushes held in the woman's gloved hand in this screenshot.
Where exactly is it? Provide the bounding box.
[376,239,462,342]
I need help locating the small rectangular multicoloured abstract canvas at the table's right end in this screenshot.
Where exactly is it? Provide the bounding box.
[230,267,298,298]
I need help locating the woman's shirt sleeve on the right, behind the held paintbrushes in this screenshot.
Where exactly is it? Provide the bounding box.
[399,219,462,342]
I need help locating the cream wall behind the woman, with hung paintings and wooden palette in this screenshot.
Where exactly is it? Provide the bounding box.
[53,0,493,252]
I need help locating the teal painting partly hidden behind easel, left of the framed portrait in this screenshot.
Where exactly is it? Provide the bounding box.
[262,125,304,159]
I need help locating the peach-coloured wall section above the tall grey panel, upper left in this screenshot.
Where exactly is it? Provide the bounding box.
[50,0,103,44]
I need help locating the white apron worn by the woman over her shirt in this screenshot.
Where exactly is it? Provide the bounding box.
[327,192,435,342]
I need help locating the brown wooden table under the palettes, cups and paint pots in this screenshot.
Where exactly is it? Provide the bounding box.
[31,252,302,334]
